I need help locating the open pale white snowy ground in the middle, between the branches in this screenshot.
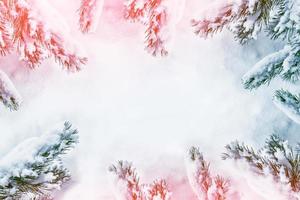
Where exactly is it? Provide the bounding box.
[0,0,297,200]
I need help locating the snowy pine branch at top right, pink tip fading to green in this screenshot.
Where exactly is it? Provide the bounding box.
[192,0,275,43]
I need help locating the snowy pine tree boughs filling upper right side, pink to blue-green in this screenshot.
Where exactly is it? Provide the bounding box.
[193,0,300,123]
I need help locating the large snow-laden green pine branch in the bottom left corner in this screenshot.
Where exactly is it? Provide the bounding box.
[0,122,78,200]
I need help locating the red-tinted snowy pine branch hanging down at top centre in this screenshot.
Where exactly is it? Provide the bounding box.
[125,0,168,56]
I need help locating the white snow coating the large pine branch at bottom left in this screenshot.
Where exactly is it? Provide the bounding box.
[0,123,76,199]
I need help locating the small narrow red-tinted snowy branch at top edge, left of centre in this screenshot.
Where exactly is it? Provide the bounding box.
[79,0,104,33]
